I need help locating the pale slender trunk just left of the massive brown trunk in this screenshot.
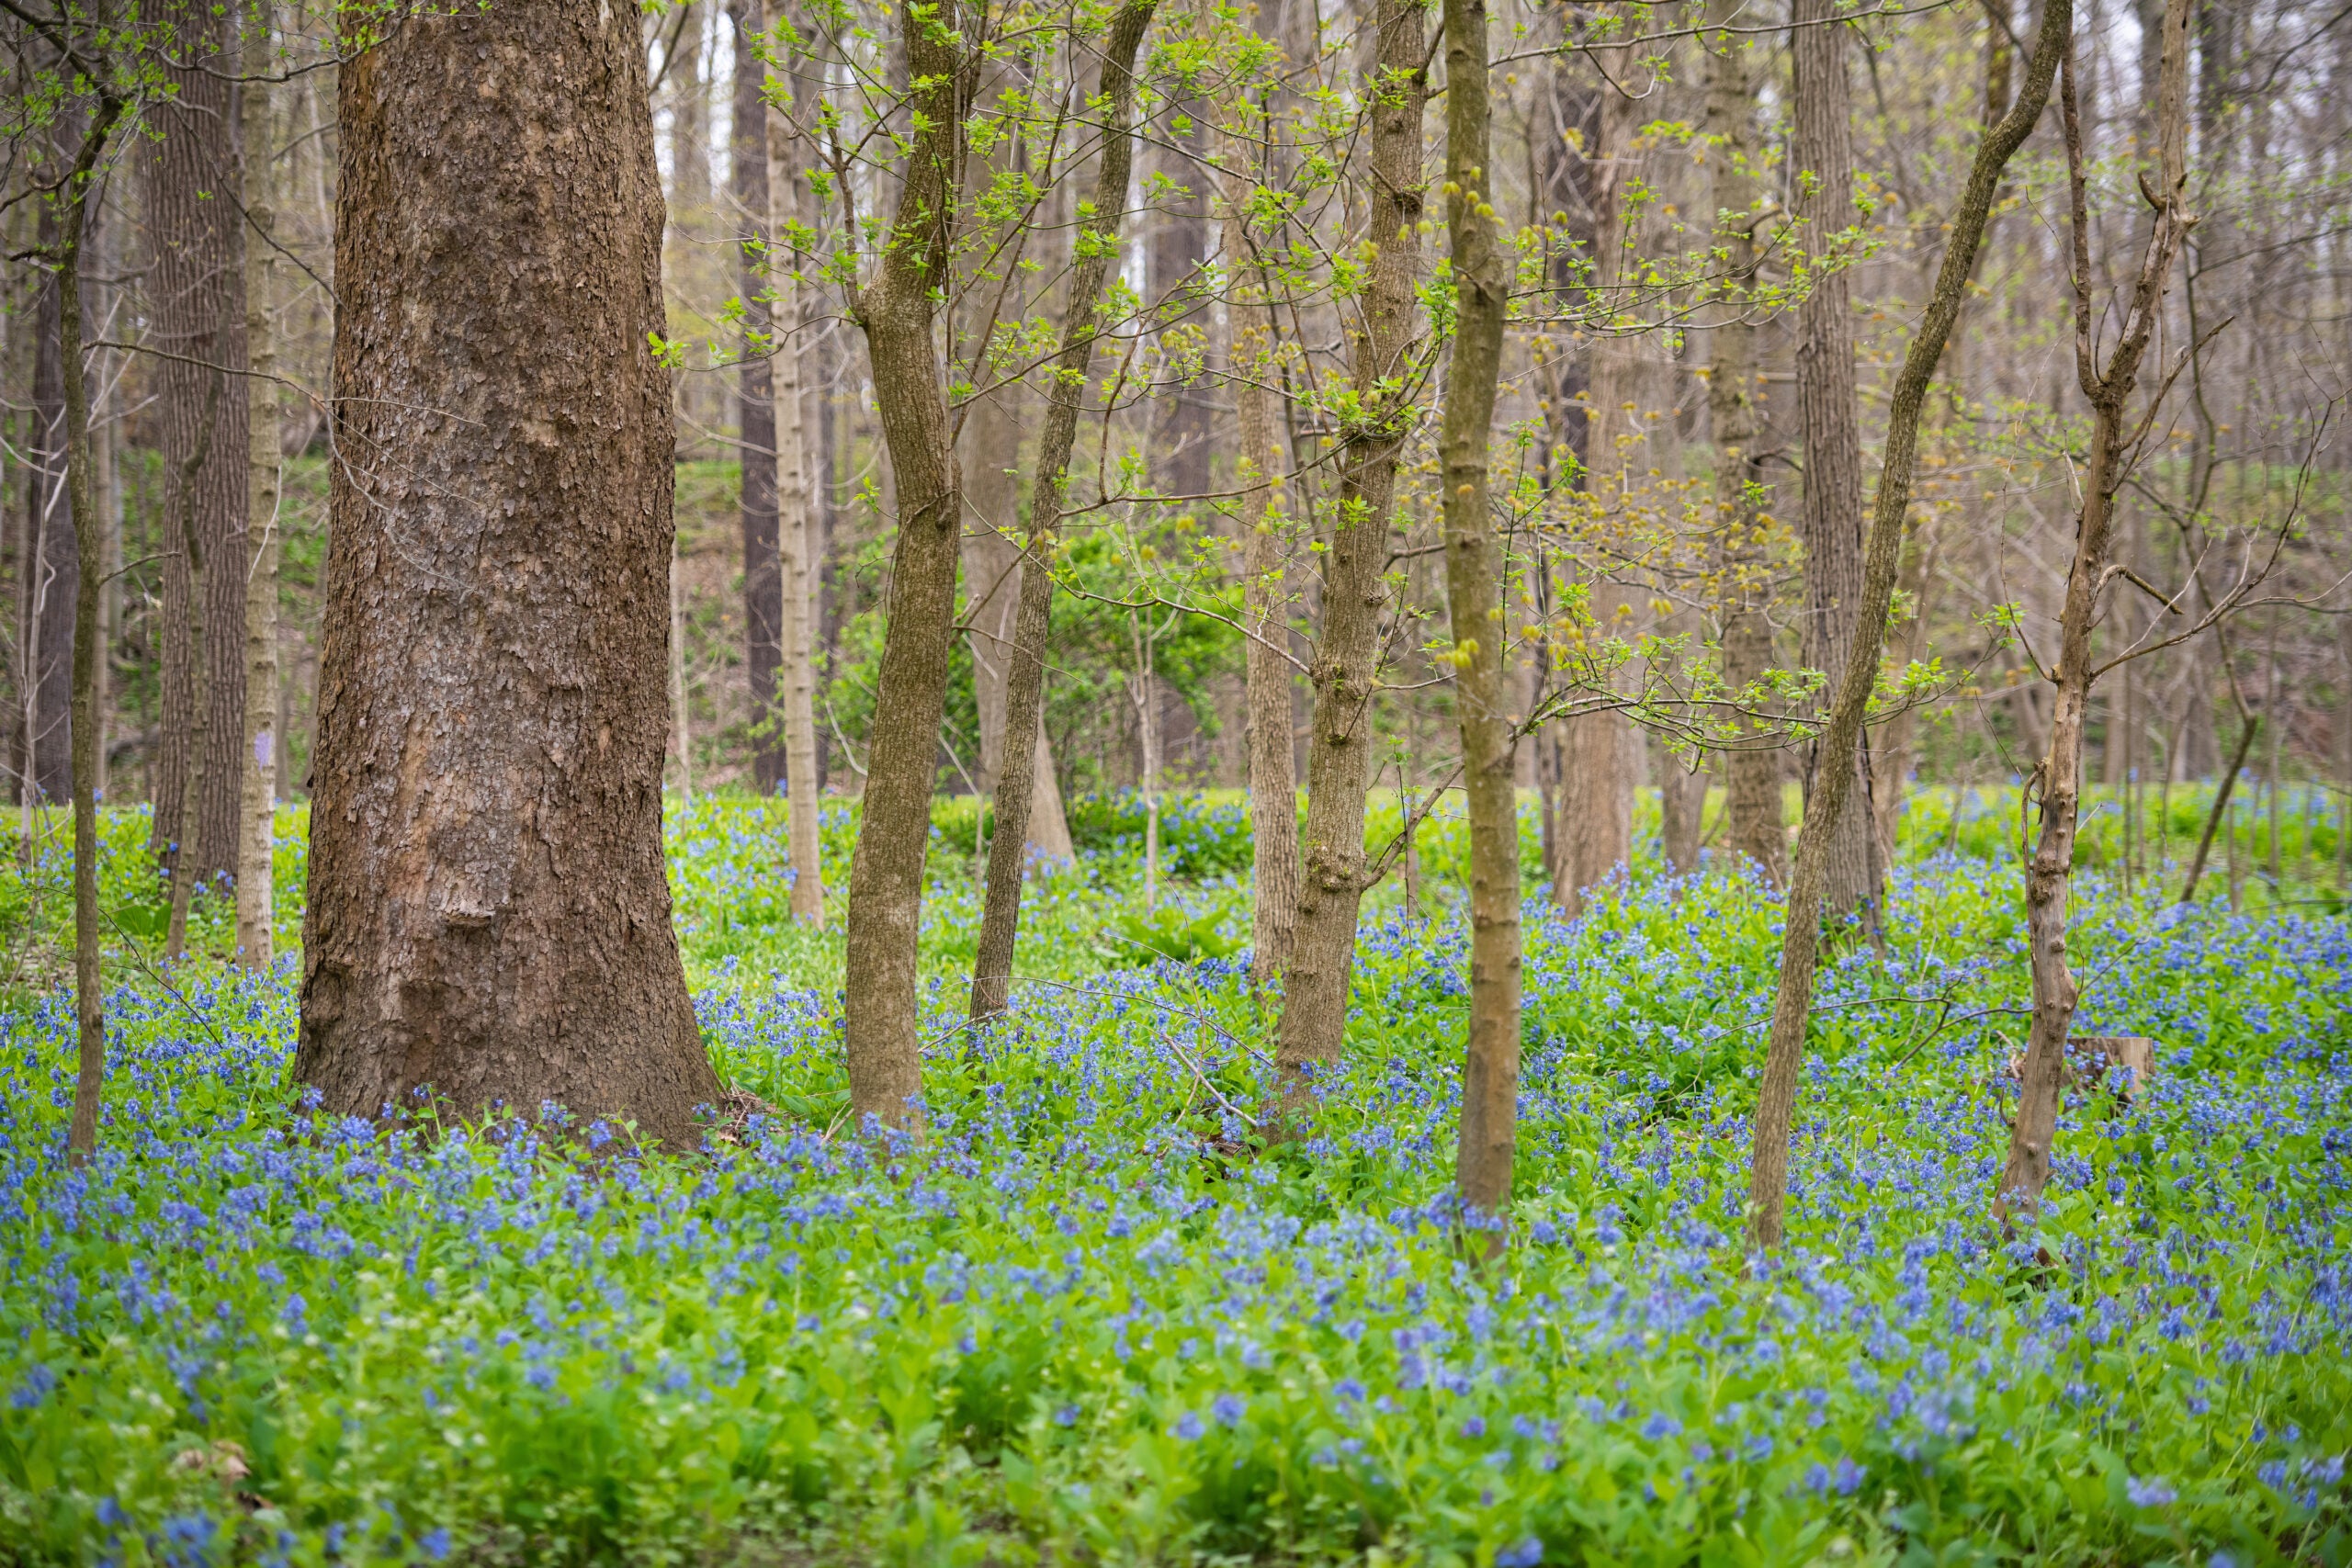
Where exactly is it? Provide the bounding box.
[238,0,280,968]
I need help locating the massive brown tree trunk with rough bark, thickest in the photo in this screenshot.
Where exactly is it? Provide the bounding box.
[308,0,718,1147]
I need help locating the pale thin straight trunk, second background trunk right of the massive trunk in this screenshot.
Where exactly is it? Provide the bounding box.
[767,21,826,926]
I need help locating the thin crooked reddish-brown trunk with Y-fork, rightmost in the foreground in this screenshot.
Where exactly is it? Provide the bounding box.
[1995,0,2191,1220]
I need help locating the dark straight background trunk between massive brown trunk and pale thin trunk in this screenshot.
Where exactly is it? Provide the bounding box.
[727,0,783,795]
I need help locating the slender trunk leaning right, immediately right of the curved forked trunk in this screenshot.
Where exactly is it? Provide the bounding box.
[971,0,1158,1022]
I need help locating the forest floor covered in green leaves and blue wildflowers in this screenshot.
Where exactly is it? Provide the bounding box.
[0,792,2352,1568]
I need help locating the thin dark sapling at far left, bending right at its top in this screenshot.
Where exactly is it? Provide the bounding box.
[56,92,122,1164]
